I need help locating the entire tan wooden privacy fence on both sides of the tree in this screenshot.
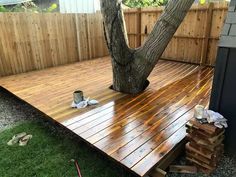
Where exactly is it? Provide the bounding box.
[0,3,227,76]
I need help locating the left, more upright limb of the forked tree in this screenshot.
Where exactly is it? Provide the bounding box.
[101,0,133,66]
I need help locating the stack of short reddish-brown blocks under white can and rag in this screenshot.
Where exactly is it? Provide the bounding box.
[185,118,225,174]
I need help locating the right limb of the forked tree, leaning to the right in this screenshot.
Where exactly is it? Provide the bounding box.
[134,0,194,77]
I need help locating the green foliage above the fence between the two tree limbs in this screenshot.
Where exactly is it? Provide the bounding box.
[123,0,168,7]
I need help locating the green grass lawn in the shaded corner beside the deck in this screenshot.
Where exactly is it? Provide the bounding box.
[0,122,136,177]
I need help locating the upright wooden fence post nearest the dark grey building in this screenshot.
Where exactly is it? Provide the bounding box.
[200,2,214,65]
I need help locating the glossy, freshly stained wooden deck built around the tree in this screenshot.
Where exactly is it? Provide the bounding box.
[0,57,213,176]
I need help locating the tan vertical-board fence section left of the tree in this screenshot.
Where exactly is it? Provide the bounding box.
[0,13,108,76]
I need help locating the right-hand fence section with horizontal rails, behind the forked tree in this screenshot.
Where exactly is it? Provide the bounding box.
[125,3,228,65]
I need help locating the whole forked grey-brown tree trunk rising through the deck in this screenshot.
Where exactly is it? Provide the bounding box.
[101,0,194,94]
